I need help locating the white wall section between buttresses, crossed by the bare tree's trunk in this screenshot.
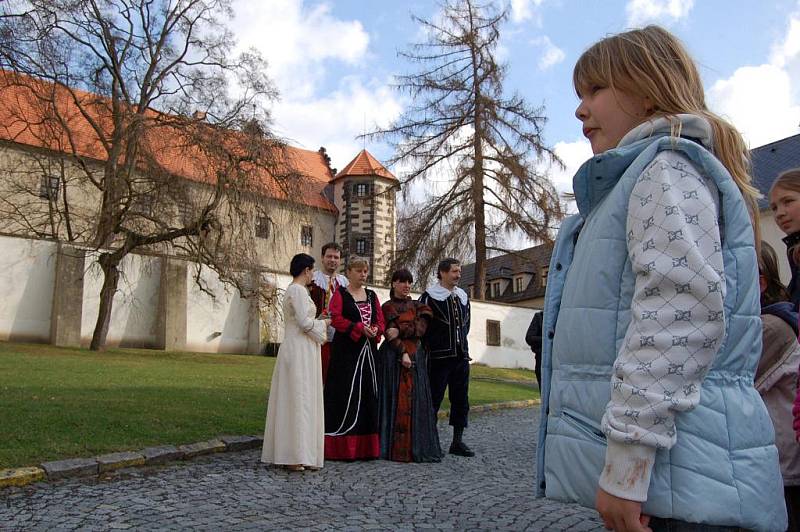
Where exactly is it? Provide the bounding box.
[81,254,161,347]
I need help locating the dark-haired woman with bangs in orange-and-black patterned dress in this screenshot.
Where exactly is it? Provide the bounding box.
[378,269,442,462]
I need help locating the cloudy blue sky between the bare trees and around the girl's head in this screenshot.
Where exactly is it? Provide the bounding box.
[232,0,800,204]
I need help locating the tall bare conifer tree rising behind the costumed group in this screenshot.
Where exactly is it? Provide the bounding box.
[369,0,563,299]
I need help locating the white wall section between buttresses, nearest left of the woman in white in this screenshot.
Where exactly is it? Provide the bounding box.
[186,264,250,353]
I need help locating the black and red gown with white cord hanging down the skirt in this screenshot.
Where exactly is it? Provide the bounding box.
[325,288,384,460]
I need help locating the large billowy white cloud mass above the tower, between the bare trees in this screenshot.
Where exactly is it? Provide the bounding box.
[231,0,402,169]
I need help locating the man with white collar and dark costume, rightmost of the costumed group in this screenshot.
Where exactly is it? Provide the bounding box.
[419,259,475,456]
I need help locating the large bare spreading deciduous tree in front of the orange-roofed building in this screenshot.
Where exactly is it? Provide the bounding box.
[0,0,298,350]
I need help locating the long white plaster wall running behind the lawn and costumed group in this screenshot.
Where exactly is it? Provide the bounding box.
[0,237,535,368]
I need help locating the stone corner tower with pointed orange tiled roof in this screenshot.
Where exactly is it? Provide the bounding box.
[333,150,400,285]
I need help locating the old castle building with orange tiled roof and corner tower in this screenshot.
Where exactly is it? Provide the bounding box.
[0,71,399,284]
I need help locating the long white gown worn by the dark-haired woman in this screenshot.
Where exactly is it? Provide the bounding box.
[261,283,327,467]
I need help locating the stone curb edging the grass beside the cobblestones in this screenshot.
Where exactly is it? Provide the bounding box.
[0,399,540,489]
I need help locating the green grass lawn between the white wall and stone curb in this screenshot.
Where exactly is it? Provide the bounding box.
[0,343,538,468]
